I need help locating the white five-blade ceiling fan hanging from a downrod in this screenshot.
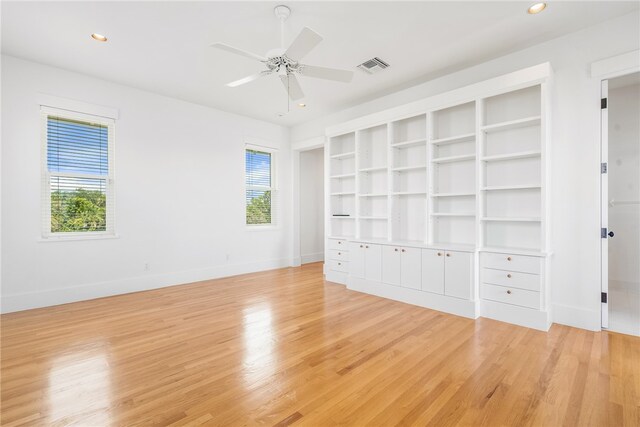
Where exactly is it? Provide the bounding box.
[211,5,353,101]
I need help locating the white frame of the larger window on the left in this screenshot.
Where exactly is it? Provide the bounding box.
[40,105,117,241]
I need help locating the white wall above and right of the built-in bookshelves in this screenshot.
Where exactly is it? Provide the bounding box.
[291,11,640,329]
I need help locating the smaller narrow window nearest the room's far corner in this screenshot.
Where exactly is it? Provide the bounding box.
[245,147,276,226]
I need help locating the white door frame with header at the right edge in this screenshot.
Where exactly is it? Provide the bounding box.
[591,50,640,329]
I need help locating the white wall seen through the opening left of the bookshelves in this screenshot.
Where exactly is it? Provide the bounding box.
[300,148,324,264]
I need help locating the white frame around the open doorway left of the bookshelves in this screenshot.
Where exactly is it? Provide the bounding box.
[291,136,328,267]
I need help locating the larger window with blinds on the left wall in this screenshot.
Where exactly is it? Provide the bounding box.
[42,107,114,237]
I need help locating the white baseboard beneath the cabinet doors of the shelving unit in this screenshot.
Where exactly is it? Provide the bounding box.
[347,276,478,319]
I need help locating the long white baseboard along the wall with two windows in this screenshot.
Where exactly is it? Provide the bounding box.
[1,258,292,313]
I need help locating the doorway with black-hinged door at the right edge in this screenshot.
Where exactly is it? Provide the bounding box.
[601,73,640,336]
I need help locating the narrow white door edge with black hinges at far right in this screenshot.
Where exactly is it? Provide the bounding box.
[600,80,611,329]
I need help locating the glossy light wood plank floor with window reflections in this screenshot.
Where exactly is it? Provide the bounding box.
[1,264,640,427]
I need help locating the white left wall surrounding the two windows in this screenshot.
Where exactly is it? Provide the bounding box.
[1,56,292,312]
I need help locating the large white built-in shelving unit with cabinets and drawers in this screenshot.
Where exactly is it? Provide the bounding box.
[326,64,551,329]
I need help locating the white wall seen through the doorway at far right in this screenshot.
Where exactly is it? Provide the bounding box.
[608,80,640,293]
